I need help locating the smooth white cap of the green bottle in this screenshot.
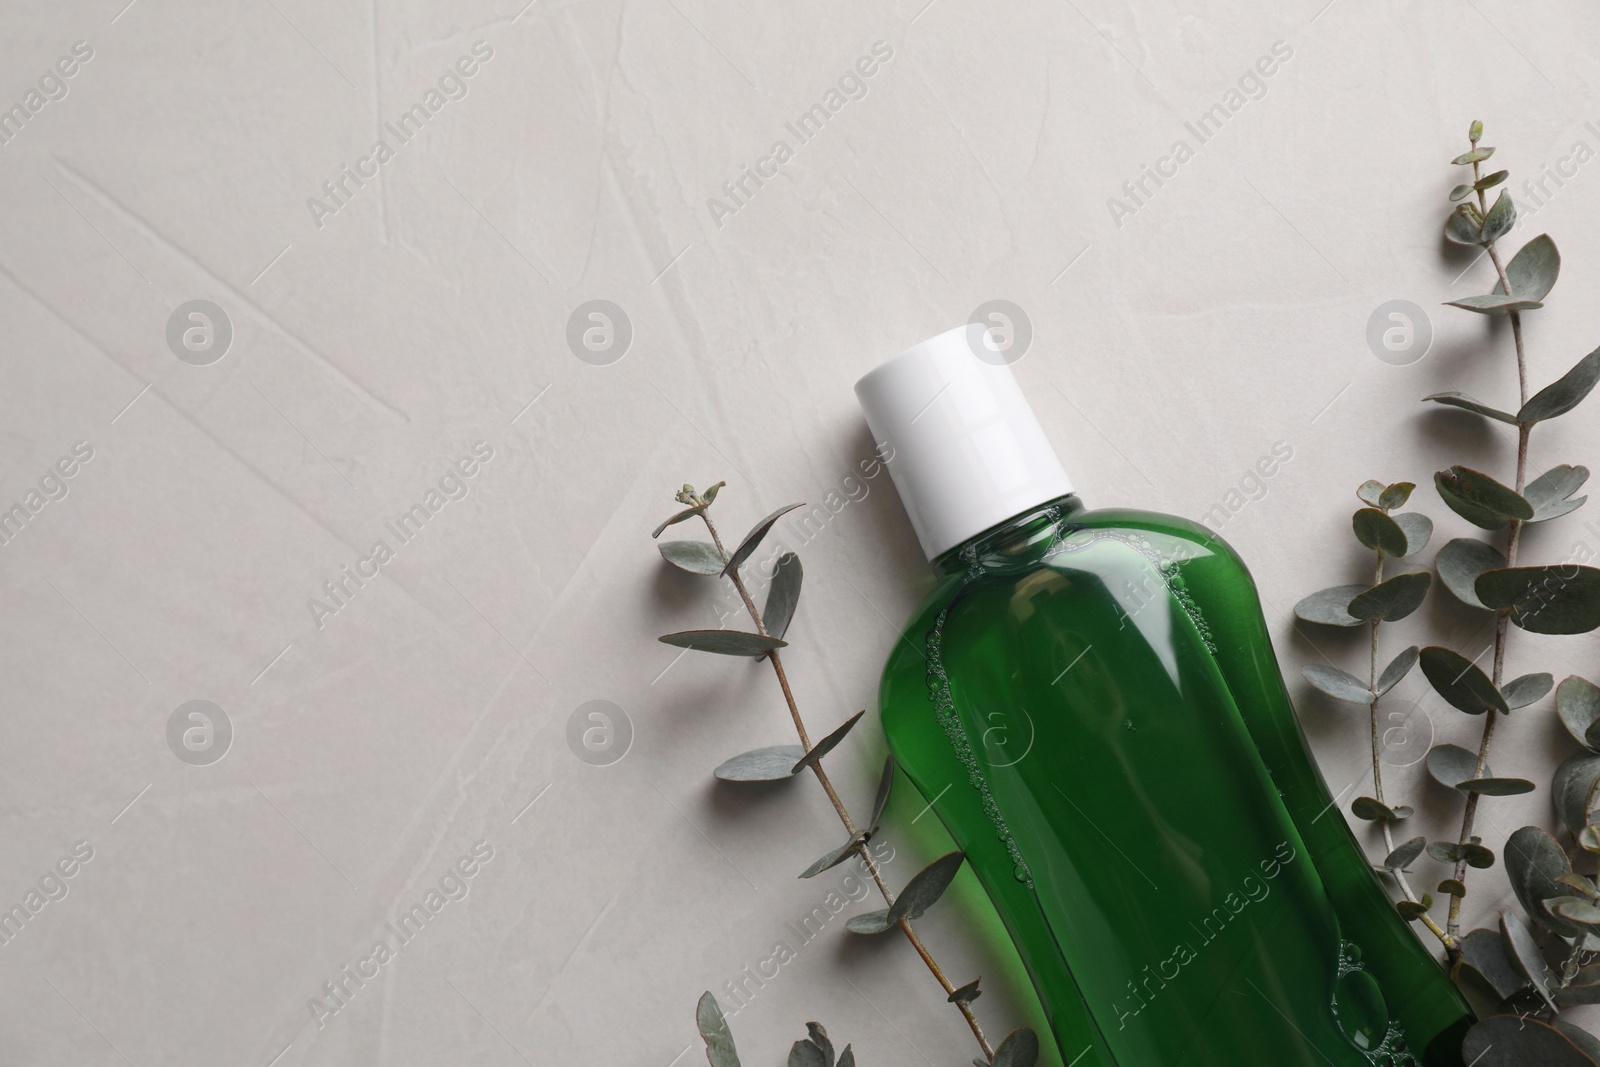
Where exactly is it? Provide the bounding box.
[856,323,1072,560]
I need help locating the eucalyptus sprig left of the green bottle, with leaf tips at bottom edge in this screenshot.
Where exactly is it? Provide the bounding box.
[656,483,1038,1067]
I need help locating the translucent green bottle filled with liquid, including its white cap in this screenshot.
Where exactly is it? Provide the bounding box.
[856,325,1472,1067]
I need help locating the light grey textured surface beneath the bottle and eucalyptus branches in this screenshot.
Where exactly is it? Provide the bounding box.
[0,0,1600,1067]
